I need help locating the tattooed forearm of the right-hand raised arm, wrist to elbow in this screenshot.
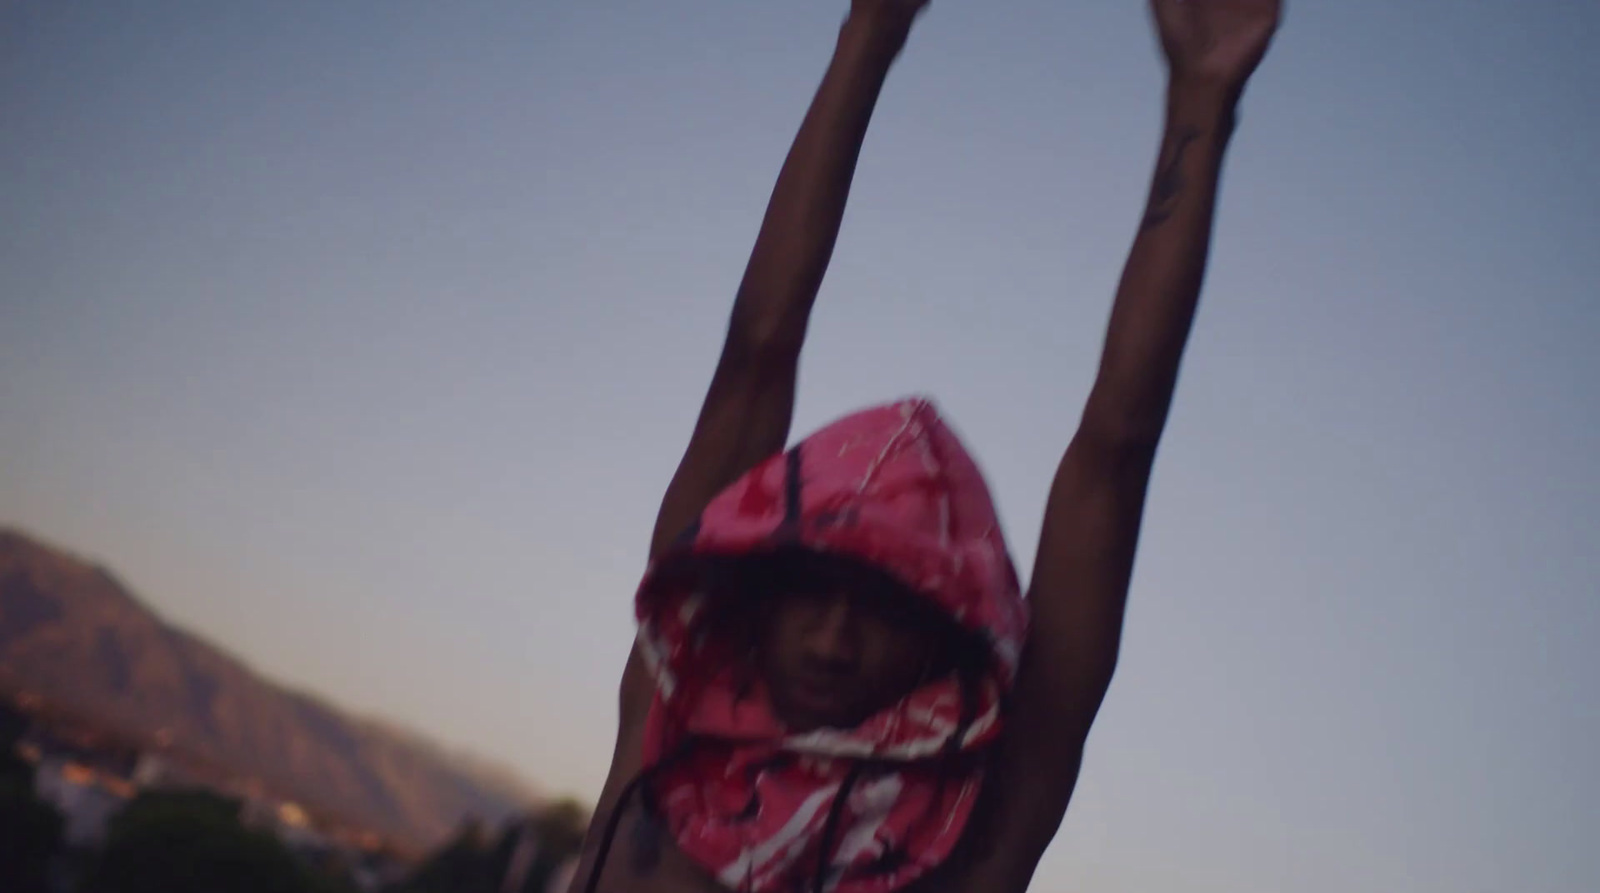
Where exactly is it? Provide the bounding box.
[1083,83,1234,451]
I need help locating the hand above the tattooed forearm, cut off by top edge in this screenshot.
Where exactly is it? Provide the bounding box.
[1150,0,1283,98]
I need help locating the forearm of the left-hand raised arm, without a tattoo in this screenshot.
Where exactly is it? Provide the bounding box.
[730,19,906,350]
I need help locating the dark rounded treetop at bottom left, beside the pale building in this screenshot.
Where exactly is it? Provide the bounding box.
[82,792,342,893]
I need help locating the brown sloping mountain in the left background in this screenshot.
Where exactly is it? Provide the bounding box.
[0,530,536,848]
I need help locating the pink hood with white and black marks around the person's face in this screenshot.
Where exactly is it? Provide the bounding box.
[635,398,1027,893]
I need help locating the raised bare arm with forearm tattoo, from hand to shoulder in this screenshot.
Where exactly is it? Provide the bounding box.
[966,0,1280,890]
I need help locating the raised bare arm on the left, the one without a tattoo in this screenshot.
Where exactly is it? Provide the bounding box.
[624,0,928,713]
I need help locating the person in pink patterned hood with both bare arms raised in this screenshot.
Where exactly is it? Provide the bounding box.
[571,0,1282,893]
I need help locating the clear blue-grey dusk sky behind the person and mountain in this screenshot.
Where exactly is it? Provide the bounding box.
[0,0,1600,893]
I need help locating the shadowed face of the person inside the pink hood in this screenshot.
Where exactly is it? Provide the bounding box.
[742,557,952,731]
